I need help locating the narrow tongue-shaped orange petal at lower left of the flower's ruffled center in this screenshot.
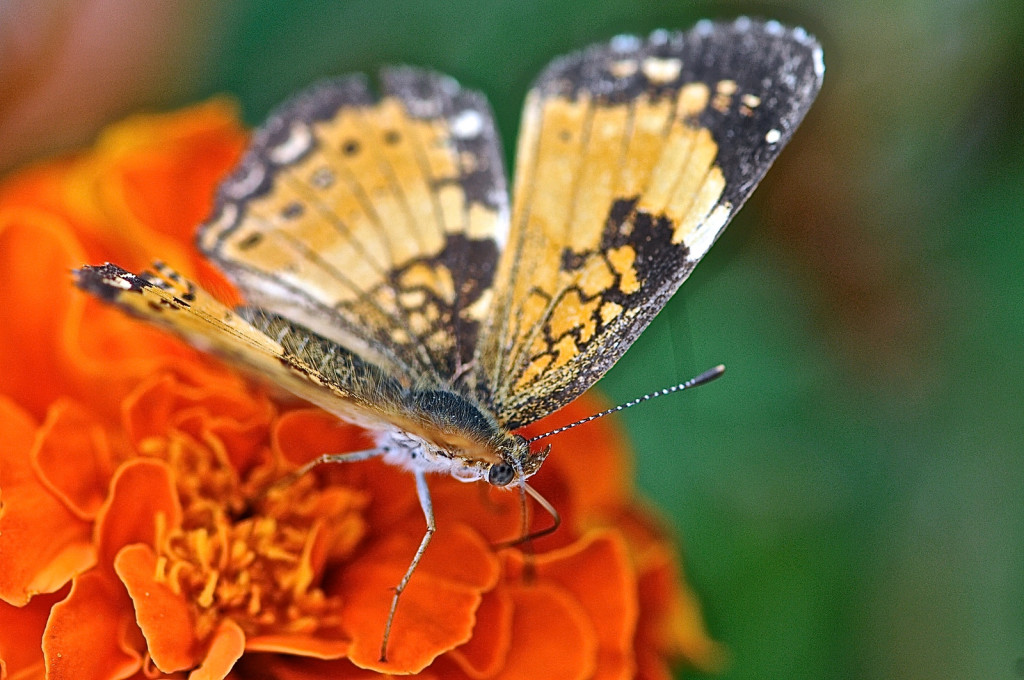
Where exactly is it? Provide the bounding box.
[114,544,201,677]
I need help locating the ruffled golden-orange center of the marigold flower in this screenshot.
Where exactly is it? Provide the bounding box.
[149,436,368,639]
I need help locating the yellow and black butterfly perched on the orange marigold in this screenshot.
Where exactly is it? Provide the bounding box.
[75,18,824,661]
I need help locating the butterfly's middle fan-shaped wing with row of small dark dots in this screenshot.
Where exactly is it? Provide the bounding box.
[199,68,508,385]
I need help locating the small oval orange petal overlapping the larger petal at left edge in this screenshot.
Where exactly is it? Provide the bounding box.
[35,399,114,520]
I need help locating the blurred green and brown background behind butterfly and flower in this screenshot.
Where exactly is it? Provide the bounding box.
[0,0,1024,680]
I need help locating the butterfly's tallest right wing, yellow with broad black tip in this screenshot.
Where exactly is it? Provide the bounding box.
[478,19,824,428]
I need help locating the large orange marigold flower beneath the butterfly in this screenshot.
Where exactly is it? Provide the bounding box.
[0,102,718,680]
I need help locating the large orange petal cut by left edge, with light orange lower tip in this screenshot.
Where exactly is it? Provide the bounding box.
[0,395,96,605]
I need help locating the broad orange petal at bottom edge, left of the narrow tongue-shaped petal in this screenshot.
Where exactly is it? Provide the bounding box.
[43,570,142,680]
